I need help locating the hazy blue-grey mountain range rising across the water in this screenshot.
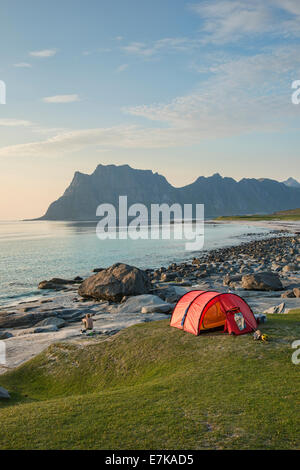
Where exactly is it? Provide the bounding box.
[41,165,300,220]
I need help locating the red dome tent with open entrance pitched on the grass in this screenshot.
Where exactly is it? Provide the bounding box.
[170,290,257,335]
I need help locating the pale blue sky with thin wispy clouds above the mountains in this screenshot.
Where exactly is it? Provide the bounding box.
[0,0,300,219]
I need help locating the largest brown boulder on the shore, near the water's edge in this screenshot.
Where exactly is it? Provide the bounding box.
[78,263,151,302]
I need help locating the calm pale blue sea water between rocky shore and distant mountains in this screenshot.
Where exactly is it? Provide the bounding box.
[0,221,269,308]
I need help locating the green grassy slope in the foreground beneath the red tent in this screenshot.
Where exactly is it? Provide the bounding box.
[0,313,300,449]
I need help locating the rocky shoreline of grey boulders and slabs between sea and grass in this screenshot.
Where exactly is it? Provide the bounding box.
[0,234,300,373]
